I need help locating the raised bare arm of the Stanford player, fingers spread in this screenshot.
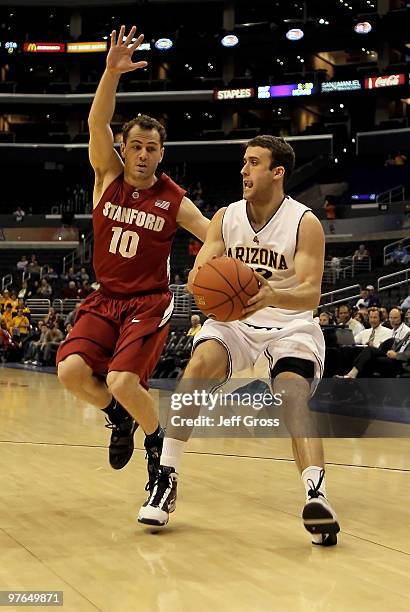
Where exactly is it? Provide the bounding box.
[88,26,147,204]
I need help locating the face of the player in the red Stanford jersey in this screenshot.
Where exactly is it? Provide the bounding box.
[121,125,164,181]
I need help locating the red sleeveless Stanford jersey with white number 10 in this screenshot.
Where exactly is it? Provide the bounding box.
[93,174,185,297]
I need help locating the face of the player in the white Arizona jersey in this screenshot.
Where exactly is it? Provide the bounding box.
[241,147,284,201]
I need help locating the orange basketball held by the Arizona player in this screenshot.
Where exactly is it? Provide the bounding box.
[193,256,259,323]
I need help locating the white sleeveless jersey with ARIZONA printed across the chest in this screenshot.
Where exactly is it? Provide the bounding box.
[222,196,313,328]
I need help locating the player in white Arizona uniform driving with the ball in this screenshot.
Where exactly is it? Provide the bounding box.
[138,136,340,546]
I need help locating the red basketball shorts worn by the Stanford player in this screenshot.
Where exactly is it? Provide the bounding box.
[57,291,172,388]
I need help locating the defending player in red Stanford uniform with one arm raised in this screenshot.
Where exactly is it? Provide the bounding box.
[57,26,209,486]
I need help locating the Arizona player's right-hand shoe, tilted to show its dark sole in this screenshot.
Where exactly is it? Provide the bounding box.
[302,470,340,546]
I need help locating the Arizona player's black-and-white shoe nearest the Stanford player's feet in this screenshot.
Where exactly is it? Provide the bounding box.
[138,465,178,527]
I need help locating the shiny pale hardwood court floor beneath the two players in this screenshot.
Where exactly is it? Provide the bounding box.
[0,368,410,612]
